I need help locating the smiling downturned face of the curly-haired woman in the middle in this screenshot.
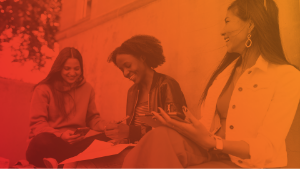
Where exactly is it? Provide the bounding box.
[116,54,147,83]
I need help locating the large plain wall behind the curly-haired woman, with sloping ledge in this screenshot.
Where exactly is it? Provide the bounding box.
[58,0,234,119]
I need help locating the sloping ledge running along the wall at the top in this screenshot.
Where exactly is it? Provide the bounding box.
[56,0,157,41]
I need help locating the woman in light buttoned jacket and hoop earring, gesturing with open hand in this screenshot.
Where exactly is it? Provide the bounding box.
[123,0,300,169]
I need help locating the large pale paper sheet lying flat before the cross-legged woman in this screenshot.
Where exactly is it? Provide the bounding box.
[60,140,135,164]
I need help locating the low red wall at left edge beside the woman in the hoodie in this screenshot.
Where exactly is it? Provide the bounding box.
[0,77,34,166]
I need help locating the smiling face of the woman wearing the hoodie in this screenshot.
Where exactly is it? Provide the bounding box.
[61,58,82,85]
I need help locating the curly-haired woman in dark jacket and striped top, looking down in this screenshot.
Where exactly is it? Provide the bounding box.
[105,35,186,143]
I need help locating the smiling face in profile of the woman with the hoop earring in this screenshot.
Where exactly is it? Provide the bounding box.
[222,10,253,54]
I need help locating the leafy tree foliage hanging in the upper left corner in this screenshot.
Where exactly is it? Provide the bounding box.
[0,0,61,69]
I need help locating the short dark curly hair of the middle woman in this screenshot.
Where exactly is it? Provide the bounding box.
[108,35,165,68]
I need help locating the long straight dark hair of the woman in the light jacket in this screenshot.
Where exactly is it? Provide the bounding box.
[200,0,289,104]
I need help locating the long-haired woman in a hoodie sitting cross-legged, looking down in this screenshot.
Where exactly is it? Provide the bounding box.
[26,47,113,168]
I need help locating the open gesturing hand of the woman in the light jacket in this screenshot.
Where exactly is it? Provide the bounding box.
[152,106,215,149]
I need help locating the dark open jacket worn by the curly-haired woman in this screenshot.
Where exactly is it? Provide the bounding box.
[126,71,186,142]
